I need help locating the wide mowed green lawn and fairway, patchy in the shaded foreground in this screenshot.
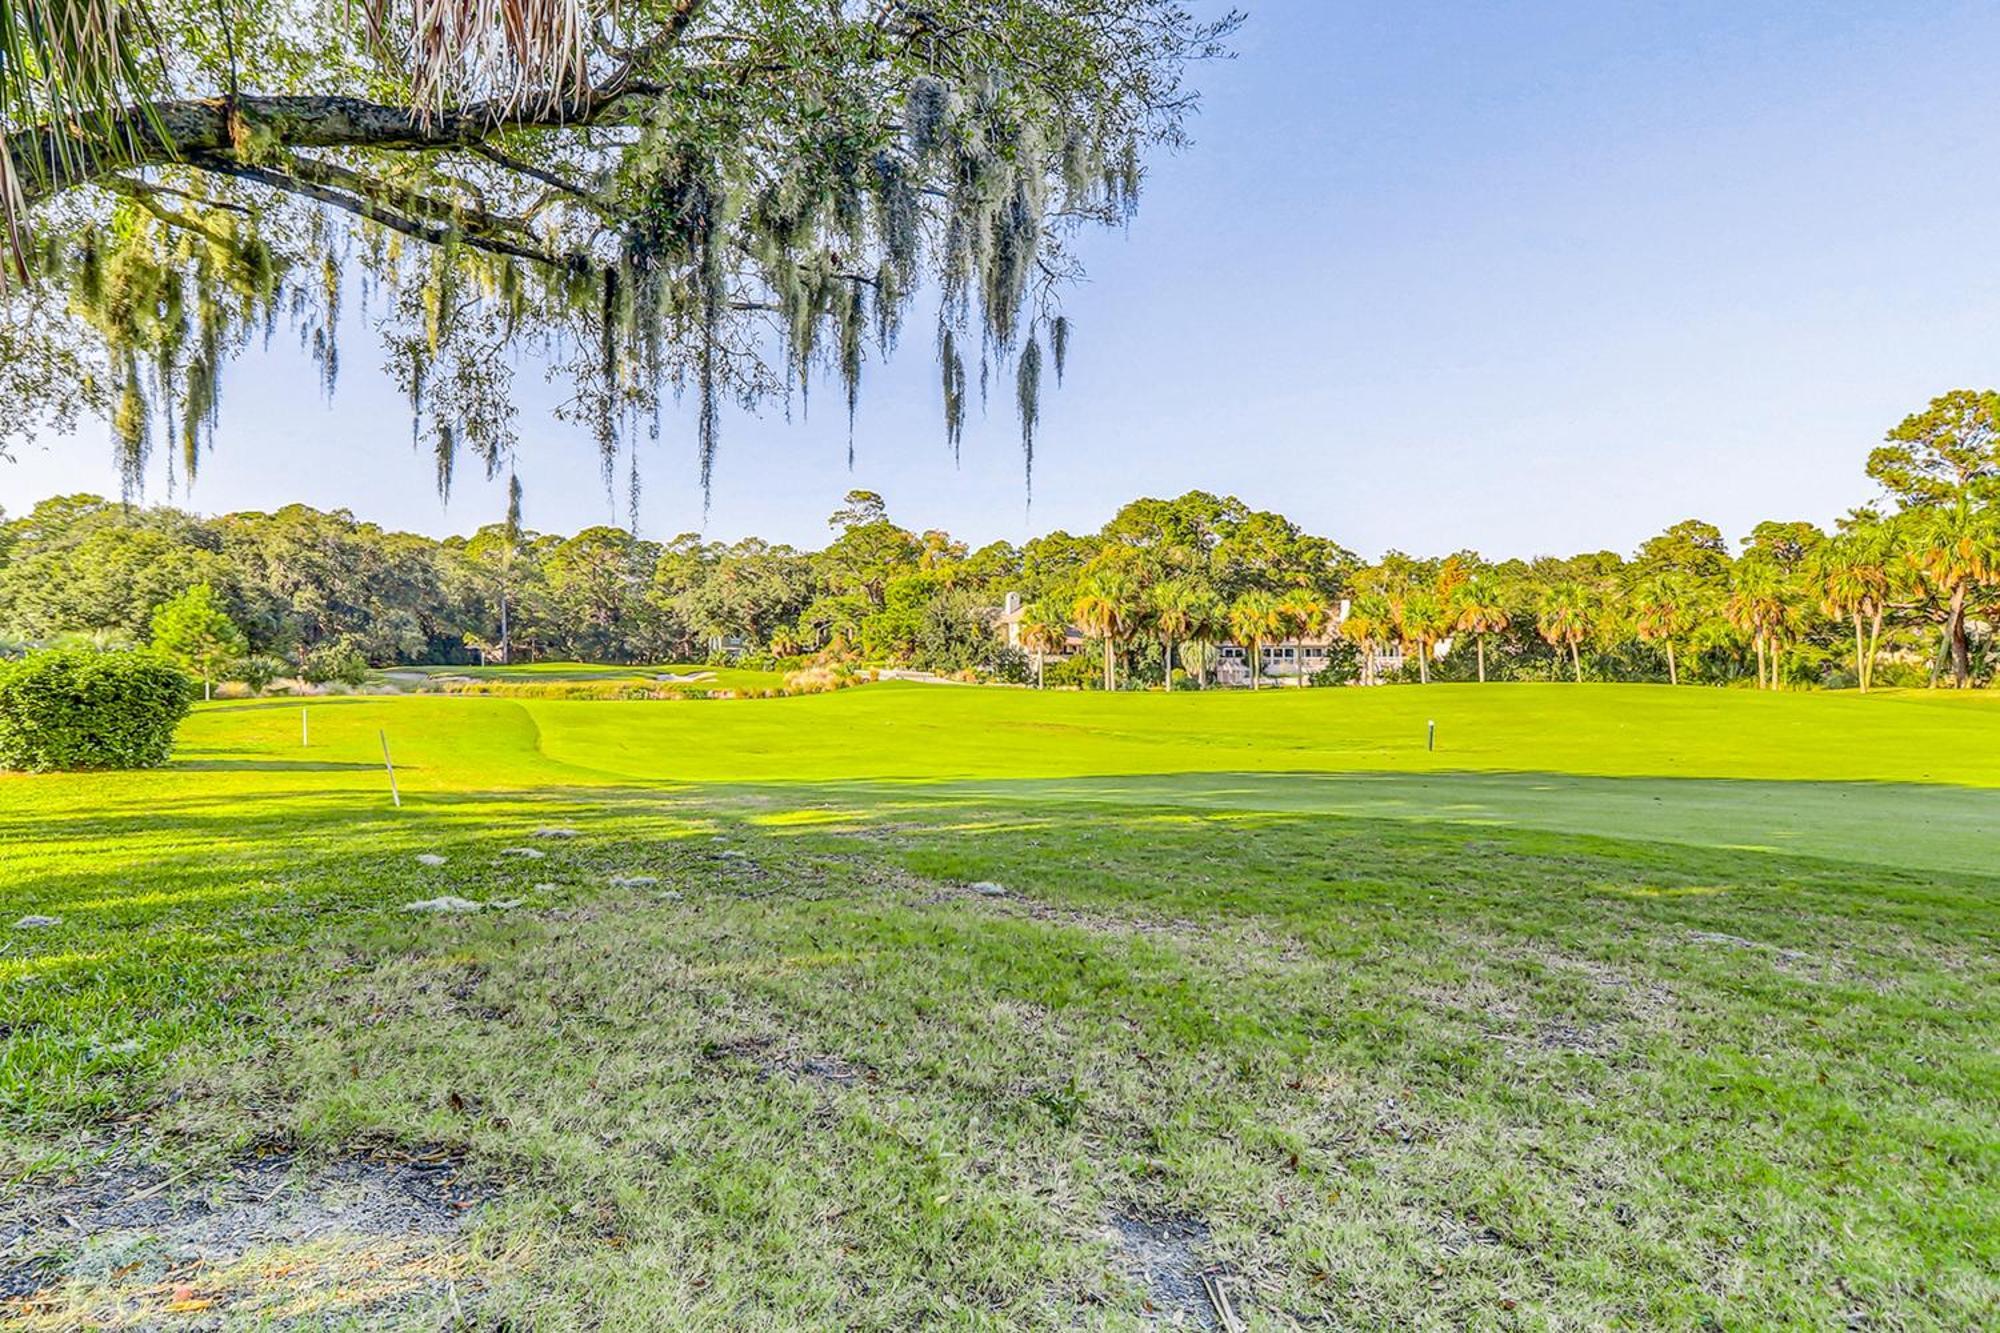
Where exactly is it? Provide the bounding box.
[0,687,2000,1329]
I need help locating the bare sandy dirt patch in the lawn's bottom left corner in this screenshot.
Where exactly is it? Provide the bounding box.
[0,1153,486,1329]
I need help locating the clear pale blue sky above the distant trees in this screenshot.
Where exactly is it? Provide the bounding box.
[0,0,2000,556]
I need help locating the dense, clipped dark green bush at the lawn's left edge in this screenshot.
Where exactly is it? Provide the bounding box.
[0,648,194,773]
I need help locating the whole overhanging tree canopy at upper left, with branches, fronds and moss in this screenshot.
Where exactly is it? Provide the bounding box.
[0,0,1238,498]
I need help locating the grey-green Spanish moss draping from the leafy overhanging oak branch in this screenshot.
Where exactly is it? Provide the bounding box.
[0,0,1234,508]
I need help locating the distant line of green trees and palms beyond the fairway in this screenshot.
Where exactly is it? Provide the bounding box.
[0,390,2000,689]
